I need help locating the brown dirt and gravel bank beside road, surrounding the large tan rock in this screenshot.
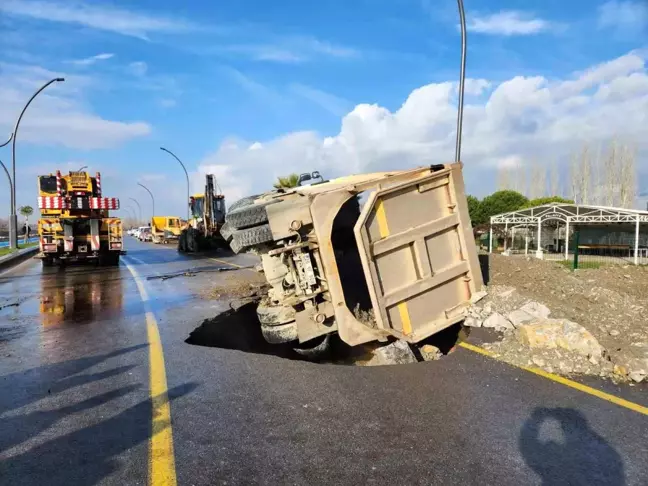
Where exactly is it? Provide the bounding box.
[474,255,648,381]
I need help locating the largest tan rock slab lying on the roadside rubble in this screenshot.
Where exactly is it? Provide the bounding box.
[516,319,604,360]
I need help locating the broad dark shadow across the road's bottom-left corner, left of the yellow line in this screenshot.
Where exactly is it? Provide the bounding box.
[0,383,197,486]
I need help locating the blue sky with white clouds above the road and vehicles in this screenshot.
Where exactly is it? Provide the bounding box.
[0,0,648,217]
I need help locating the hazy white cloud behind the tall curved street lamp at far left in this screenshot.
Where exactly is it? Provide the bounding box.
[0,64,151,149]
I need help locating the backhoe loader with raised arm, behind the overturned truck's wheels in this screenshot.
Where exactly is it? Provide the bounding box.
[178,174,229,252]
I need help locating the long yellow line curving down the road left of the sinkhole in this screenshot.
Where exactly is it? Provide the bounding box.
[126,264,177,486]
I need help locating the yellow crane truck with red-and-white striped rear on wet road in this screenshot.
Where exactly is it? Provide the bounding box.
[37,171,126,266]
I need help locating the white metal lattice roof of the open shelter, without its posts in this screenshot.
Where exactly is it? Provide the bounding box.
[490,203,648,224]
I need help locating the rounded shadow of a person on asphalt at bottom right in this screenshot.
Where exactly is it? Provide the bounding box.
[519,407,625,486]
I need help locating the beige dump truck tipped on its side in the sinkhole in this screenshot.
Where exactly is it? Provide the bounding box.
[222,163,482,354]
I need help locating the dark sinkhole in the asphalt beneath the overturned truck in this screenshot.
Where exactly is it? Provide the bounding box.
[185,301,467,366]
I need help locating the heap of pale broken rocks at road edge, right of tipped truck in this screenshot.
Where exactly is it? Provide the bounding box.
[464,285,648,382]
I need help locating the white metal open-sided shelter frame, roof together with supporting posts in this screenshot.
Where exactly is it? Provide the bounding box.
[488,203,648,265]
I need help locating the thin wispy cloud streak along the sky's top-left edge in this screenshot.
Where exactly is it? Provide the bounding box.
[0,0,195,40]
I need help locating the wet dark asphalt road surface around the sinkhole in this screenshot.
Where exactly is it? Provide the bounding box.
[0,239,648,486]
